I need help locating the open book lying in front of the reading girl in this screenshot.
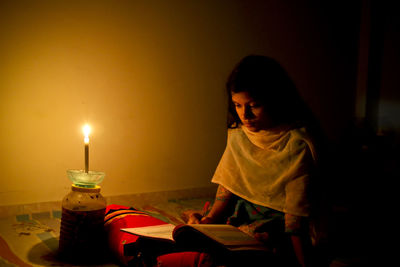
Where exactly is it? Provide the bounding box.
[121,224,269,251]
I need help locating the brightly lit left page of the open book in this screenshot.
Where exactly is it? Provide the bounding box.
[121,223,175,241]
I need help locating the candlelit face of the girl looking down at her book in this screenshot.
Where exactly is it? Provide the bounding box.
[232,92,273,132]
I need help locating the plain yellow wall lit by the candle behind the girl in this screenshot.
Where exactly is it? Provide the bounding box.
[0,0,362,205]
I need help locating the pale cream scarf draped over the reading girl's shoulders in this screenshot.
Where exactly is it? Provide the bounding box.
[212,126,315,216]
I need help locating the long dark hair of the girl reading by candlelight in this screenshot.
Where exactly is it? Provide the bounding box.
[226,55,311,128]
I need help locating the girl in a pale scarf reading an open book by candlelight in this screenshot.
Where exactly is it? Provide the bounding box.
[188,55,324,266]
